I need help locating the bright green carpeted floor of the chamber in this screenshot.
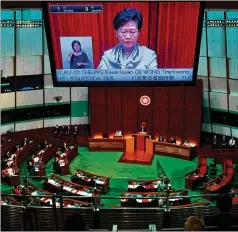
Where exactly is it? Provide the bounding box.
[2,147,225,207]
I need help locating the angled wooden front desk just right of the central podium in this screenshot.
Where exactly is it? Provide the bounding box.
[154,142,197,160]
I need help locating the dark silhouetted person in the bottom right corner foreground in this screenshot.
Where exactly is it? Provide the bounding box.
[204,194,238,228]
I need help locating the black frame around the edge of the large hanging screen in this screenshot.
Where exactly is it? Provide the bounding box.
[42,1,205,87]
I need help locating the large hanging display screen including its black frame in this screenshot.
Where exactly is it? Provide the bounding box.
[44,2,203,86]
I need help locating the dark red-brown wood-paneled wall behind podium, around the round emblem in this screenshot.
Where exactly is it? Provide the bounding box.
[89,80,202,145]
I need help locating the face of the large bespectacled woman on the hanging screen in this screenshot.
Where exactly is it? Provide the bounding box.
[116,20,140,49]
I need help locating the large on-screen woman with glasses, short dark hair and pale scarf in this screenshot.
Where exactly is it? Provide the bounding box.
[98,8,158,69]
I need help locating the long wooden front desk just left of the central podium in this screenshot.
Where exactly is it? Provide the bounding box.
[88,138,126,151]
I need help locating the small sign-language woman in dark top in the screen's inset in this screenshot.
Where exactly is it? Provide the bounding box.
[67,40,89,69]
